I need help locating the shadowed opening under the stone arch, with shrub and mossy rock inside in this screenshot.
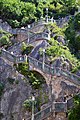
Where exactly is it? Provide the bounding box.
[29,70,49,109]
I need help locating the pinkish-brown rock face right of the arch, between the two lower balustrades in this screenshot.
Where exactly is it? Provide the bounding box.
[52,76,80,102]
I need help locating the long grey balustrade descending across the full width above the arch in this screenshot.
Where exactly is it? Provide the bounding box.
[2,49,80,86]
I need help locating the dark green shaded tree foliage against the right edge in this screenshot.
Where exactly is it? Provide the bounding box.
[65,13,80,58]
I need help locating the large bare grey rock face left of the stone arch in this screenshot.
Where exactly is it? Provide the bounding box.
[0,58,32,120]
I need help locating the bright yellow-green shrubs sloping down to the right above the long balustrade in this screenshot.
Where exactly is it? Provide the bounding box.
[46,39,80,72]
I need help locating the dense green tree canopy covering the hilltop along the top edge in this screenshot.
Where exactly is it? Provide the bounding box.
[0,0,78,27]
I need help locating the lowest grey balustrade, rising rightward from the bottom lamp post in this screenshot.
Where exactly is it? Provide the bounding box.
[26,98,74,120]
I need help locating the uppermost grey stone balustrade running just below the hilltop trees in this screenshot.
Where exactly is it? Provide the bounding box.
[0,15,74,34]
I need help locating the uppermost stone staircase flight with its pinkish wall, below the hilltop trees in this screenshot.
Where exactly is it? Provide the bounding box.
[0,15,74,34]
